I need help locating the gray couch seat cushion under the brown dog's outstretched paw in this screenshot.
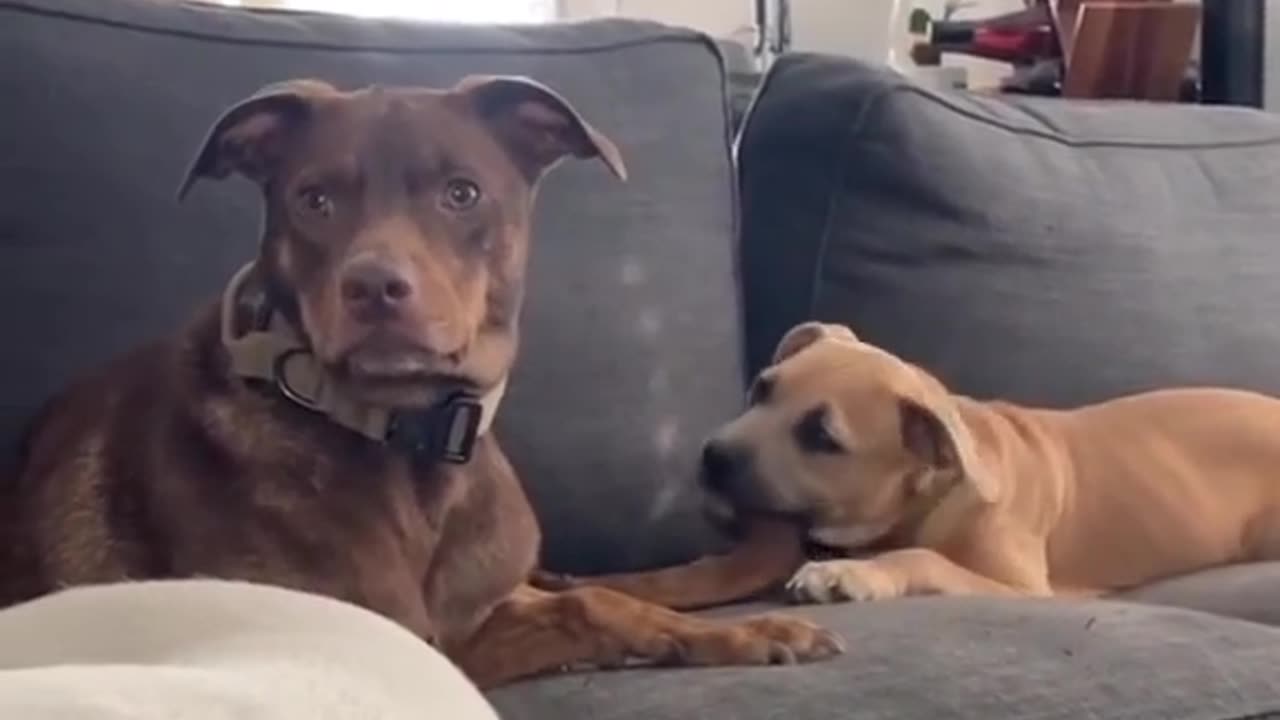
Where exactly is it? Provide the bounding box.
[490,587,1280,720]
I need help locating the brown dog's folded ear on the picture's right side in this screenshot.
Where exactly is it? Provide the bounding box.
[453,76,627,181]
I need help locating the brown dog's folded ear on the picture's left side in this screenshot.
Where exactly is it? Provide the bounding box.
[178,79,337,200]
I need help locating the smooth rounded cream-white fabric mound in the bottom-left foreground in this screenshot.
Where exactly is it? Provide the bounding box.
[0,580,497,720]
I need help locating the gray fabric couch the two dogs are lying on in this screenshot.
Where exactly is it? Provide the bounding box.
[0,0,1280,720]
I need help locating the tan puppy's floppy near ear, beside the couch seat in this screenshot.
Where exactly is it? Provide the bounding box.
[899,391,1000,502]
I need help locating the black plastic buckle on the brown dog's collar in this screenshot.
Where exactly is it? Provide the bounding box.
[387,392,484,465]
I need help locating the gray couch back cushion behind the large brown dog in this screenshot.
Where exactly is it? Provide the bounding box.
[0,0,741,573]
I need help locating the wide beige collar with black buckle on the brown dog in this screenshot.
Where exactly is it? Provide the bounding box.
[221,263,507,464]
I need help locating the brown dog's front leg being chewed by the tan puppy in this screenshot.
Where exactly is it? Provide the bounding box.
[531,518,805,610]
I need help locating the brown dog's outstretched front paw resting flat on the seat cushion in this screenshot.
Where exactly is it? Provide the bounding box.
[680,614,845,665]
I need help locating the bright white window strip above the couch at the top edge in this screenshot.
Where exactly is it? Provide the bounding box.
[223,0,557,23]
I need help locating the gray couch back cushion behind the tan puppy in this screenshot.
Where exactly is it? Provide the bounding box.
[739,55,1280,405]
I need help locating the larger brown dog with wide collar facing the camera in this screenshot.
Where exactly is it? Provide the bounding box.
[0,77,838,685]
